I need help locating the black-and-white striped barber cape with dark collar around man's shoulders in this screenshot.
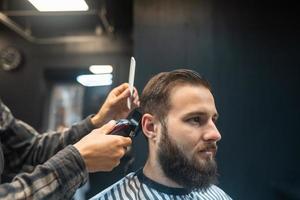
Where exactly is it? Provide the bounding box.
[91,169,231,200]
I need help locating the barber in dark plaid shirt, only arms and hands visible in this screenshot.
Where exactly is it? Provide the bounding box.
[0,83,139,200]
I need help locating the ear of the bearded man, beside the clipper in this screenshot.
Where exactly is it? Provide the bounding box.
[141,113,158,140]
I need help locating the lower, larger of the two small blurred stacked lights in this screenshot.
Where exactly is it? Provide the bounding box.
[76,74,112,87]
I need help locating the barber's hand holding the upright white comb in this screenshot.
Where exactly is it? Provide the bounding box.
[91,83,140,127]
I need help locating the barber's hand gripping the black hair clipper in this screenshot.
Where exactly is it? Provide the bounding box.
[74,120,131,172]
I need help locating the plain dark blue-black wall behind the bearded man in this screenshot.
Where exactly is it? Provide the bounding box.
[134,0,300,199]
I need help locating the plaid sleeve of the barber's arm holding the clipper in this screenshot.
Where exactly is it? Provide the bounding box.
[0,145,88,200]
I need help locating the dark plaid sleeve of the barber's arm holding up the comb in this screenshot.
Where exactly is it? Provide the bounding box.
[1,117,94,174]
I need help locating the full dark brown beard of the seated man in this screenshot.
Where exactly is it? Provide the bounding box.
[157,123,217,190]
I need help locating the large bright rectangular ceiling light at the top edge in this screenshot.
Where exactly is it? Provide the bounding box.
[28,0,89,12]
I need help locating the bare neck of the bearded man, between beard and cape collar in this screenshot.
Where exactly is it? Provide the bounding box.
[143,159,182,188]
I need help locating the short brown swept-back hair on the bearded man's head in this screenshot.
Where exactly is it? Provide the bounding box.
[140,69,211,122]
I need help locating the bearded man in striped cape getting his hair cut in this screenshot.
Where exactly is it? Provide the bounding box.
[93,70,231,200]
